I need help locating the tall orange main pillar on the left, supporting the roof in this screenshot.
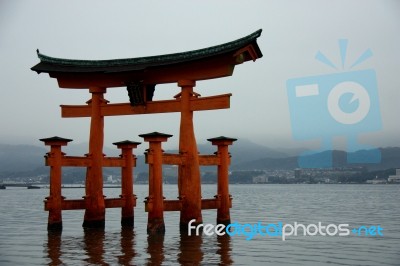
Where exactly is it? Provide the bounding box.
[82,87,106,227]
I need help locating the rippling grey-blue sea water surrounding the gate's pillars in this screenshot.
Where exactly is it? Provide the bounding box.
[0,185,400,266]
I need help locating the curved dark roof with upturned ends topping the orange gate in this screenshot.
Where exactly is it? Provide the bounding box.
[31,29,262,88]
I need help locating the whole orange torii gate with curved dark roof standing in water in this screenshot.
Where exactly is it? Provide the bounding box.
[31,30,262,233]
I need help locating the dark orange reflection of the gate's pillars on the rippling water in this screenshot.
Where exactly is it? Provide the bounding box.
[44,228,233,265]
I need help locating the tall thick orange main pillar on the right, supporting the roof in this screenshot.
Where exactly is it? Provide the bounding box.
[178,80,203,231]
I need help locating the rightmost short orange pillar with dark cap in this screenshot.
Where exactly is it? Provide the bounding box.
[208,137,237,225]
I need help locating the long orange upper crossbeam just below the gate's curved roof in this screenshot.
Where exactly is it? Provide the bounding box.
[61,93,232,118]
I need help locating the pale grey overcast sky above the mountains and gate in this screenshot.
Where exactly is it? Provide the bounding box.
[0,0,400,153]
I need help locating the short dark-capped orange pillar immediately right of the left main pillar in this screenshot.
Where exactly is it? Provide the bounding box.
[113,140,140,227]
